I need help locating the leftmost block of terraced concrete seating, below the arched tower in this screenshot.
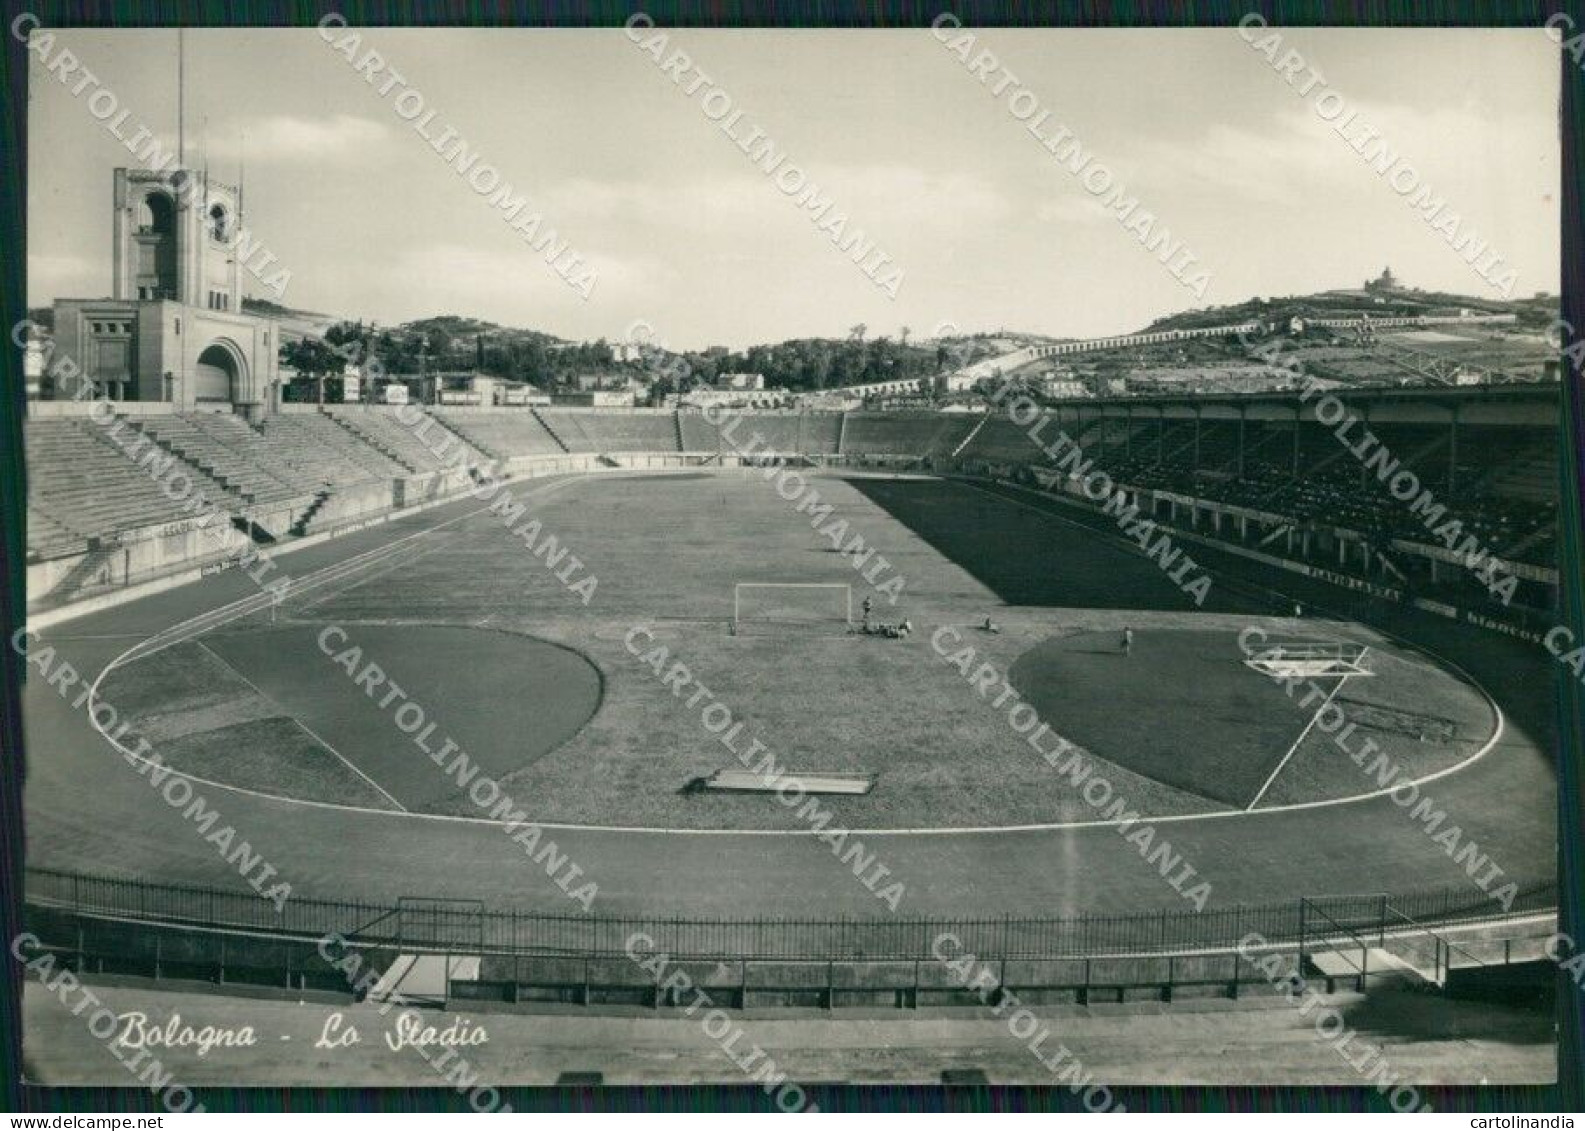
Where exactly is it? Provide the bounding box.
[24,420,241,553]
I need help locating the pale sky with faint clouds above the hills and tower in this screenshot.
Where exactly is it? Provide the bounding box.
[27,29,1560,348]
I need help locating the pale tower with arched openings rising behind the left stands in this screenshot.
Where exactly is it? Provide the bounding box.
[40,168,281,417]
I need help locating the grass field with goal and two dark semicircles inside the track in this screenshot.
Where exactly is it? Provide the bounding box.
[105,474,1491,828]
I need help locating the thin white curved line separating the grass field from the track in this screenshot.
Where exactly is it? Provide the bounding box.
[68,475,1507,836]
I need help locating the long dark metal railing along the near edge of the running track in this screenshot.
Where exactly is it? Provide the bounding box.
[25,868,1556,960]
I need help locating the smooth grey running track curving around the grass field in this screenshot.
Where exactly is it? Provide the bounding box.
[24,472,1566,919]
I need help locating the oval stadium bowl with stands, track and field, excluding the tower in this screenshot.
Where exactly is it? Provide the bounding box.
[25,321,1556,1079]
